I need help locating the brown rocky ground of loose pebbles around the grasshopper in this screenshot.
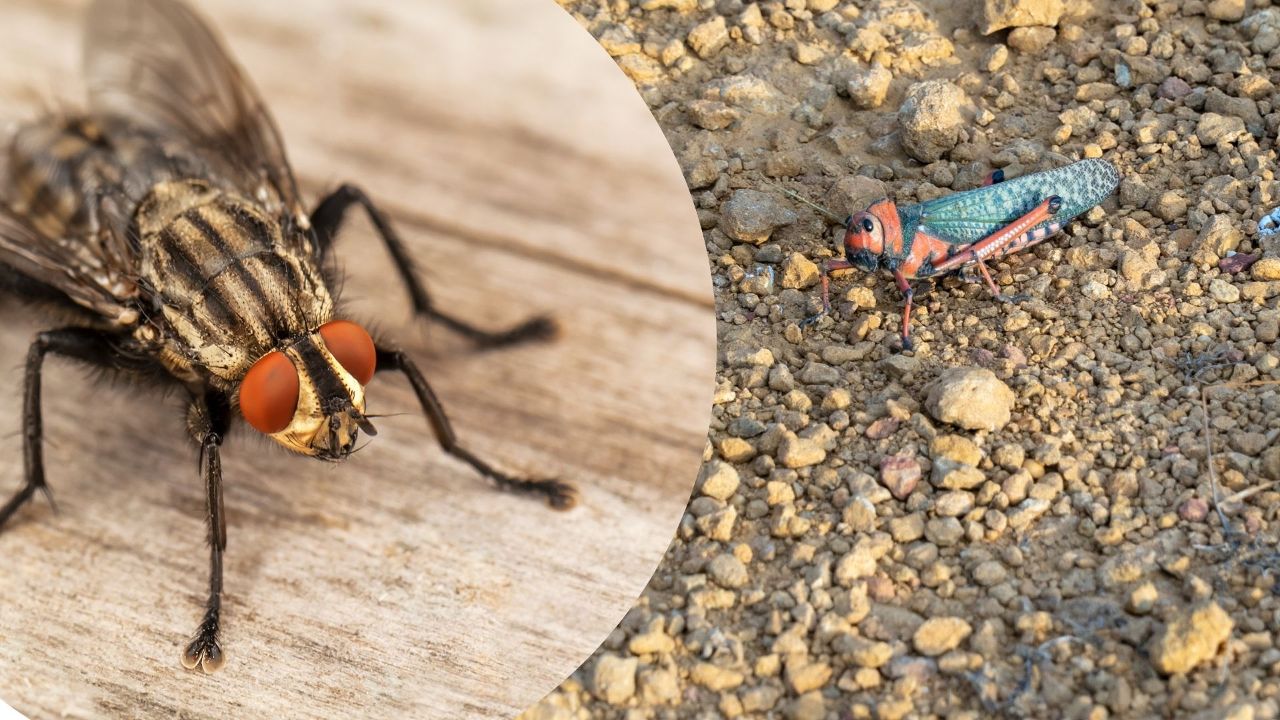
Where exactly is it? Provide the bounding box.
[526,0,1280,720]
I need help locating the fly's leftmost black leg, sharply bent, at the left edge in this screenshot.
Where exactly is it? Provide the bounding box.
[0,328,144,527]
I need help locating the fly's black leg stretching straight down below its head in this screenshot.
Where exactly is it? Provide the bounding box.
[182,392,230,673]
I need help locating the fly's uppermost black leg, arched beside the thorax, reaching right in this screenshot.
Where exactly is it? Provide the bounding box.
[311,184,557,347]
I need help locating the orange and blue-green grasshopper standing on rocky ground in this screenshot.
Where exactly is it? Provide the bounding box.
[805,159,1120,350]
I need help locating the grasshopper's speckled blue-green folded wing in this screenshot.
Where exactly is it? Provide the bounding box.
[913,159,1120,245]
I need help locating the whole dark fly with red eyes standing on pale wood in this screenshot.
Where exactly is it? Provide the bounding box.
[0,0,576,673]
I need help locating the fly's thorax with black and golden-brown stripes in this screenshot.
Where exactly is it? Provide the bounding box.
[137,179,333,384]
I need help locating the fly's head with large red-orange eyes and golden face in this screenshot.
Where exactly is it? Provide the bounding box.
[239,320,378,462]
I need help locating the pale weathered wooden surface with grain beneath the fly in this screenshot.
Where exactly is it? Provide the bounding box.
[0,0,714,717]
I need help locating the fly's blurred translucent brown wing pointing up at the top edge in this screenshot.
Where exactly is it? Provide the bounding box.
[84,0,305,248]
